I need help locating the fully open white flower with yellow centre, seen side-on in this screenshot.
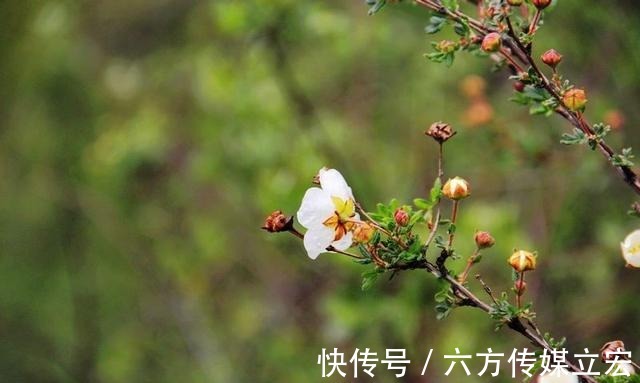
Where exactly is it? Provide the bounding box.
[298,168,360,259]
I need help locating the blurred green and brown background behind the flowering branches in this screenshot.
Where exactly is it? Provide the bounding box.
[0,0,640,383]
